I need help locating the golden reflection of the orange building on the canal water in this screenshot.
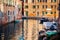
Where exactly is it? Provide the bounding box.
[24,19,39,40]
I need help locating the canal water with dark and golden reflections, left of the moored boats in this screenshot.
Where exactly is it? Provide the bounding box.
[0,19,43,40]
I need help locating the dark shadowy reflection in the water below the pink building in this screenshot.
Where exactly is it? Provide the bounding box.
[0,22,22,40]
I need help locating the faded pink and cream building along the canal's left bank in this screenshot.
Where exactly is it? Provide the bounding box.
[0,0,22,23]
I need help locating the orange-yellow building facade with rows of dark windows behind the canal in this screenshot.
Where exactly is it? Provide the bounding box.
[24,0,59,18]
